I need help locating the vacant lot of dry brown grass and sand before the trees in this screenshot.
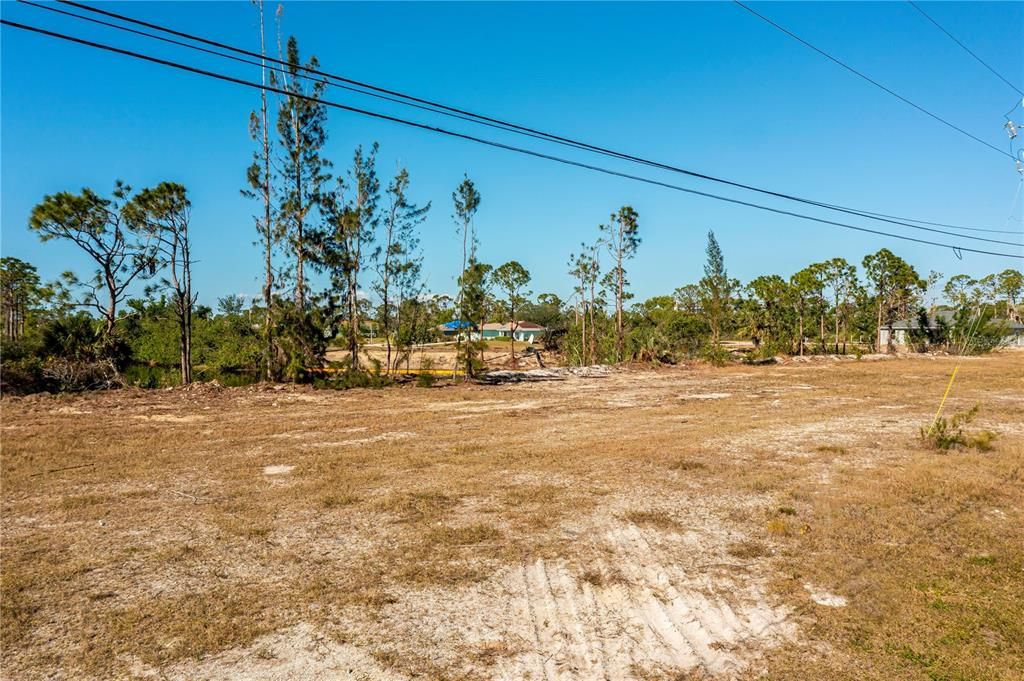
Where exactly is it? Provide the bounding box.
[0,353,1024,680]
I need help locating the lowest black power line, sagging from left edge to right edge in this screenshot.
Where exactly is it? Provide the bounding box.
[0,18,1024,259]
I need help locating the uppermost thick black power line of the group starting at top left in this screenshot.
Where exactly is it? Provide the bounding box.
[34,0,1018,237]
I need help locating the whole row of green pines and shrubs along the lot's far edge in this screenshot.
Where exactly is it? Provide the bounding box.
[0,3,1024,393]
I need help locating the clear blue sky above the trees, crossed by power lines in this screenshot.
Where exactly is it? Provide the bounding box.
[0,2,1024,304]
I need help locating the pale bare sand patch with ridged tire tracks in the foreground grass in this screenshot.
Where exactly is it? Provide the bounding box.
[500,525,790,681]
